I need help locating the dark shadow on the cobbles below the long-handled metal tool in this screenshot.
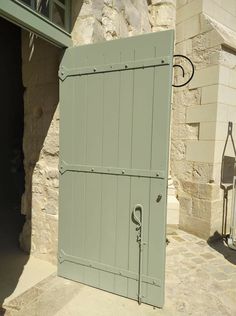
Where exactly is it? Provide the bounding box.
[207,232,236,265]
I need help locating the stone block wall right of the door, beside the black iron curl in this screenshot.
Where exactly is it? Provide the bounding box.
[171,0,236,239]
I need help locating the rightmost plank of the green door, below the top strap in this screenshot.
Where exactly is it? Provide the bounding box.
[148,67,170,306]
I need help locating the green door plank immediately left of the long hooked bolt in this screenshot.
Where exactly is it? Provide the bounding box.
[115,49,134,296]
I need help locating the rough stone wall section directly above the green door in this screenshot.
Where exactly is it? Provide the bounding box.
[72,0,176,45]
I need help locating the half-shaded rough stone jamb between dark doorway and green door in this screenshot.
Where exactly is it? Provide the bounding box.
[20,31,61,262]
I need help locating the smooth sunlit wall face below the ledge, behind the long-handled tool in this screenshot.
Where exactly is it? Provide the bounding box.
[209,48,236,233]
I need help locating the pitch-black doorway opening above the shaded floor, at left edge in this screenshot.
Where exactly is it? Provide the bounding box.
[0,19,24,248]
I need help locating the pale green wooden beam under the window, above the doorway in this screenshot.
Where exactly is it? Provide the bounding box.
[0,0,72,48]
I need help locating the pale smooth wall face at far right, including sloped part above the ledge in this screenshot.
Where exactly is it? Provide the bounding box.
[203,0,236,234]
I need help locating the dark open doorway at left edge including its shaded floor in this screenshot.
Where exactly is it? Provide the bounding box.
[0,18,27,306]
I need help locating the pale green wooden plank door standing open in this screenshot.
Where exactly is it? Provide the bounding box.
[58,31,173,307]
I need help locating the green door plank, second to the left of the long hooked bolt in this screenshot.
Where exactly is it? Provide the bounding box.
[100,45,120,292]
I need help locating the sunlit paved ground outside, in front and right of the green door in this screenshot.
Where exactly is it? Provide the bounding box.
[2,230,236,316]
